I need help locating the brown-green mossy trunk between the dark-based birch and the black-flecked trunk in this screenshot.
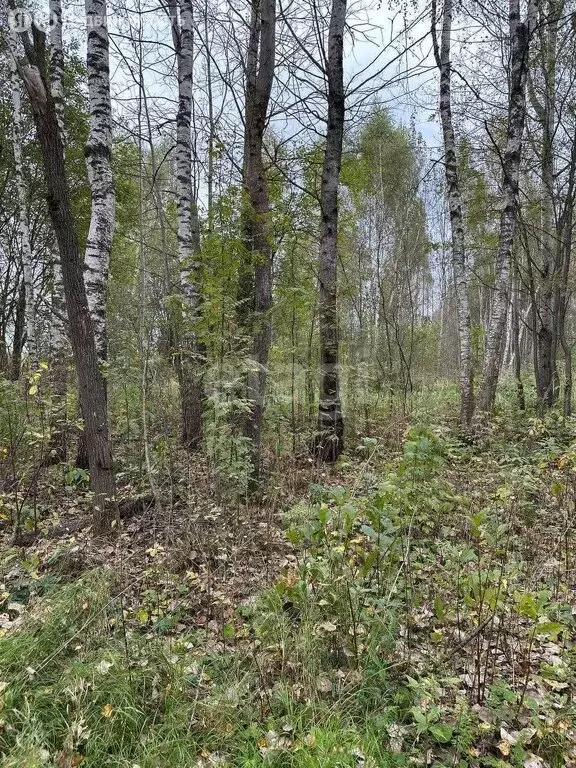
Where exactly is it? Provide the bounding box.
[241,0,276,478]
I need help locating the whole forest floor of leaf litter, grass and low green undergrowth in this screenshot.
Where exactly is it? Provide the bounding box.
[0,404,576,768]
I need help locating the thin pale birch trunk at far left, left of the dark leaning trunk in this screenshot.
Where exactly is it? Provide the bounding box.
[10,33,38,370]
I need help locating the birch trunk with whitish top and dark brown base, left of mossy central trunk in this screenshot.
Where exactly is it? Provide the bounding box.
[168,0,204,450]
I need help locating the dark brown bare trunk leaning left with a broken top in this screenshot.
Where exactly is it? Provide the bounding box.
[19,21,118,533]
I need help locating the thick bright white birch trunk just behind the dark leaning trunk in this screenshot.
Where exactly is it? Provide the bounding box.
[84,0,116,363]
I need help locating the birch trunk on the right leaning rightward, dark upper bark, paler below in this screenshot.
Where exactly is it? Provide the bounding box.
[476,0,535,422]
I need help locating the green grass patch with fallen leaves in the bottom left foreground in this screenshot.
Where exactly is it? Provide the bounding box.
[0,572,400,768]
